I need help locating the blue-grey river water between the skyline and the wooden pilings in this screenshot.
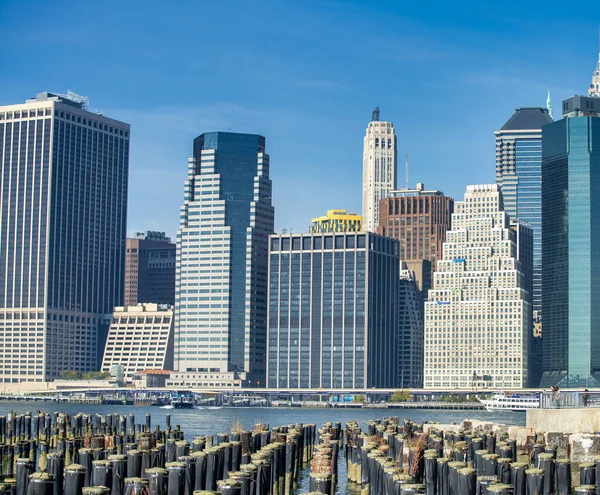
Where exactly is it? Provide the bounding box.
[0,401,525,495]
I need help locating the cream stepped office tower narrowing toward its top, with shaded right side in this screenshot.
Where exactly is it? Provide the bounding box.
[424,184,533,388]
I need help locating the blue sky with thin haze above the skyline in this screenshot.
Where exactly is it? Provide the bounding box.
[0,0,599,235]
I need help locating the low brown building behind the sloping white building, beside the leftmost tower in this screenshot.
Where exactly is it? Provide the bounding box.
[125,231,176,306]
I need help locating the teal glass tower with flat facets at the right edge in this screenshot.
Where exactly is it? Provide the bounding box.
[540,96,600,387]
